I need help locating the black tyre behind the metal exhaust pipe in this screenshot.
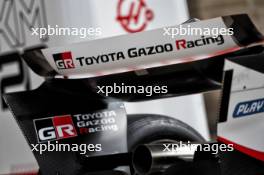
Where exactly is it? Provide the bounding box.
[128,114,204,151]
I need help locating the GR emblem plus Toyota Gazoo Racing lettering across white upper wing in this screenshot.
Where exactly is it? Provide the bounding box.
[53,35,225,69]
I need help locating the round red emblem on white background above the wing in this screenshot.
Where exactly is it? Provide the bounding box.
[117,0,154,33]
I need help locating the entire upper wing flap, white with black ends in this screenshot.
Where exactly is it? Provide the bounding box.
[24,14,263,78]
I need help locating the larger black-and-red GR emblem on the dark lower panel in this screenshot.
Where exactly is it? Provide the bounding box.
[34,115,77,142]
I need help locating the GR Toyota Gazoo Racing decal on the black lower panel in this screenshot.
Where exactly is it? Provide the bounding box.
[33,110,118,142]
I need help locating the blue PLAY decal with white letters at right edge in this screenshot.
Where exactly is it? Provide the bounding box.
[233,98,264,118]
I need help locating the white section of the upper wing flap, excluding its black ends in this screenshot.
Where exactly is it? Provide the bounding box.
[42,18,238,78]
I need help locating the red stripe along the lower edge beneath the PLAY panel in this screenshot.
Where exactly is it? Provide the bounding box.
[217,136,264,161]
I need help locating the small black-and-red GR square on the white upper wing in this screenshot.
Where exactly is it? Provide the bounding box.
[53,52,75,69]
